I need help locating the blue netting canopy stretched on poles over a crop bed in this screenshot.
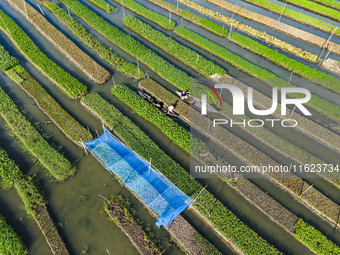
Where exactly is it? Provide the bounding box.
[84,130,193,227]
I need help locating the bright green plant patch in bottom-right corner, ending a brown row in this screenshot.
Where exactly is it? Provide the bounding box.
[295,219,340,255]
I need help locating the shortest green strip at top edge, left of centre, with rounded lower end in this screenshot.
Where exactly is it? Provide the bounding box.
[113,0,176,30]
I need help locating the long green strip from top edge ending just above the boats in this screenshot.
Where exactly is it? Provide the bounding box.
[60,0,190,89]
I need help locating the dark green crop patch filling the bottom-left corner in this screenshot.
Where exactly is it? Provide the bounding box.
[0,214,27,255]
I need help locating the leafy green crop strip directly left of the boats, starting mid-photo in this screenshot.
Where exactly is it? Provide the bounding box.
[111,85,205,153]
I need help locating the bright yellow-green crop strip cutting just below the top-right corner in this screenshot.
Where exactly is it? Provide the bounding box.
[280,0,340,21]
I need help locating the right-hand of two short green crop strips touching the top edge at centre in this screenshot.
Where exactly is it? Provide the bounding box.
[145,0,229,37]
